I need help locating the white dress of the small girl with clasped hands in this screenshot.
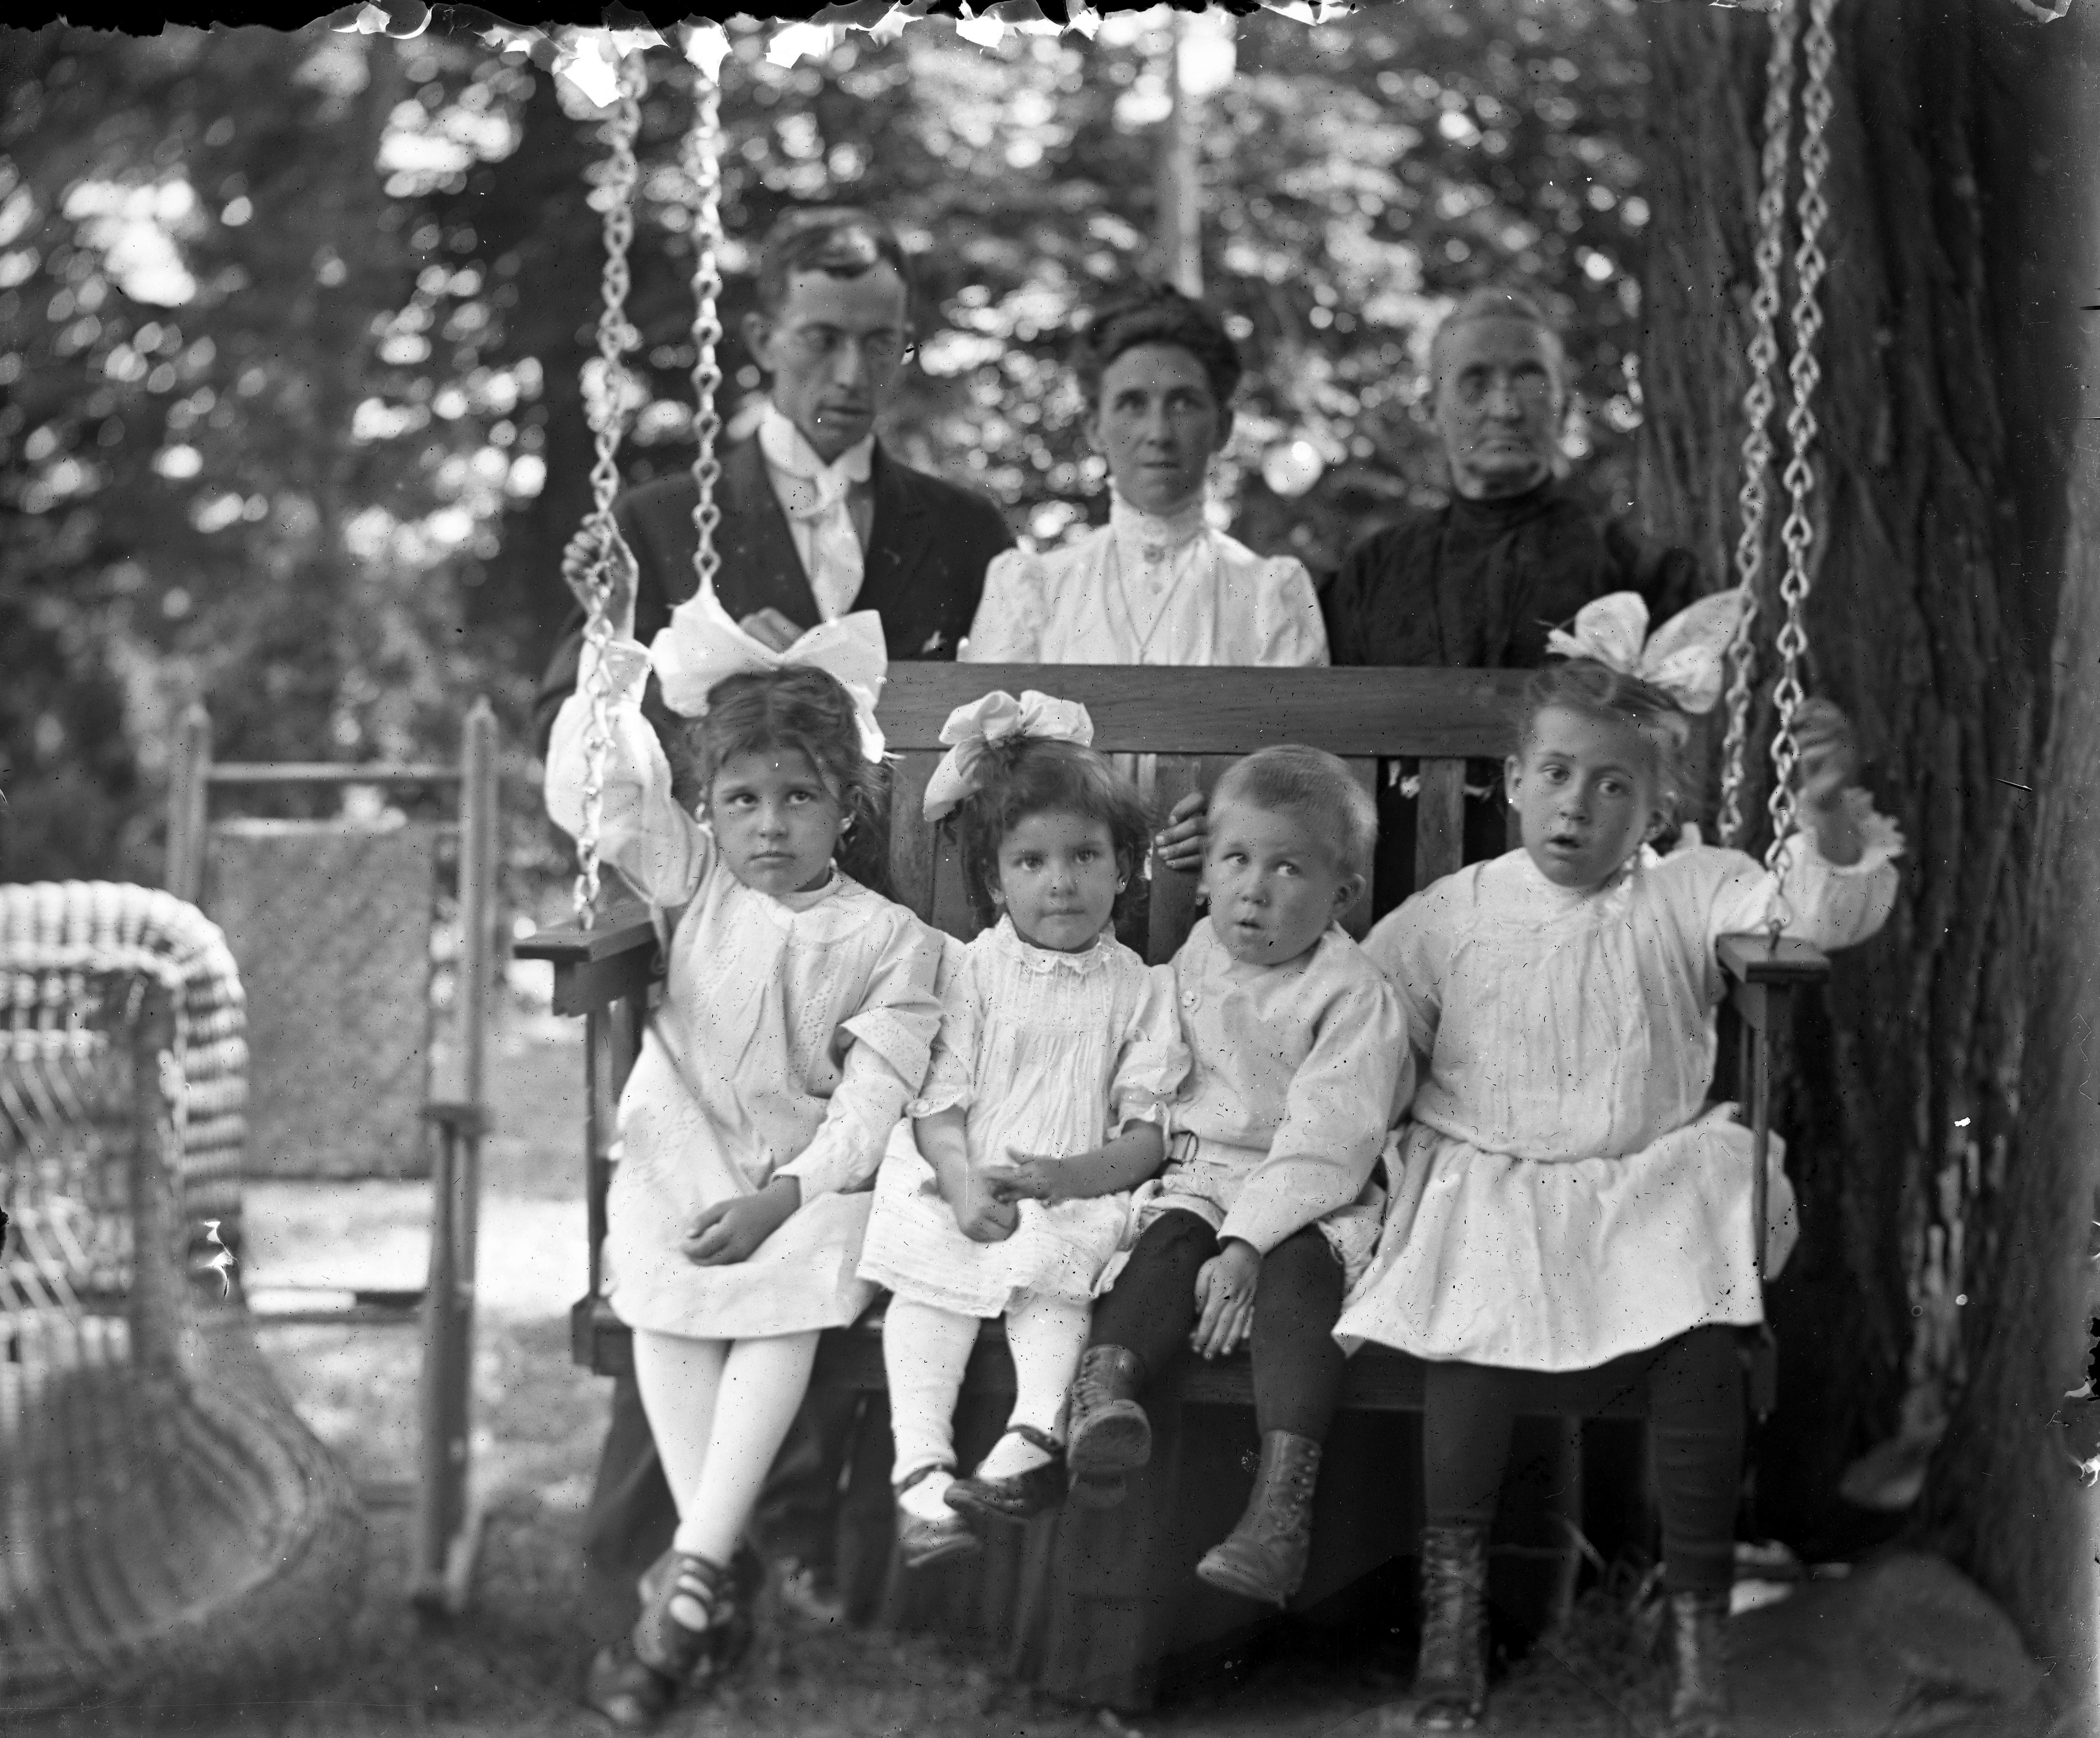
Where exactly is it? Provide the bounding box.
[861,917,1189,1318]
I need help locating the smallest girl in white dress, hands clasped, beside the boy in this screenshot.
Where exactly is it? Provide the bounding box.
[861,693,1189,1568]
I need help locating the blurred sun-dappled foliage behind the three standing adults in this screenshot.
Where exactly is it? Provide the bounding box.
[0,0,1647,911]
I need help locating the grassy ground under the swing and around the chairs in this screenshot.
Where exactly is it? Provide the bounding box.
[12,1012,2049,1738]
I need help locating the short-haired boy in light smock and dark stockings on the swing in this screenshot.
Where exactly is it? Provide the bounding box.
[1008,747,1413,1606]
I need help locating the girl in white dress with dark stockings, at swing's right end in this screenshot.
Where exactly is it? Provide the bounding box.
[1336,592,1900,1738]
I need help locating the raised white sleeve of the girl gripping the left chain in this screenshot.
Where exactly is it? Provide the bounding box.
[546,640,714,907]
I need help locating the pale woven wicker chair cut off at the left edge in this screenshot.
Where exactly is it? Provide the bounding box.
[0,882,366,1723]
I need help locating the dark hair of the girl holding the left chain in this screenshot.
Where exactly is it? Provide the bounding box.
[687,666,890,898]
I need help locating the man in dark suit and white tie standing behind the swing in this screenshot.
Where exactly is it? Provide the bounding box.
[536,208,1012,1713]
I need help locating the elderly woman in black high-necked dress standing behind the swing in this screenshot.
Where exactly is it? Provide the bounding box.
[1325,290,1699,905]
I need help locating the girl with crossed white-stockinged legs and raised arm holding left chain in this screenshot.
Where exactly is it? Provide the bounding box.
[546,583,941,1727]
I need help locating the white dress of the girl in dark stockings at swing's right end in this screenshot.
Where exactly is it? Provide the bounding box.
[1336,815,1900,1371]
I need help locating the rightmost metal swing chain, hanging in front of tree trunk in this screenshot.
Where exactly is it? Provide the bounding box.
[1764,0,1837,934]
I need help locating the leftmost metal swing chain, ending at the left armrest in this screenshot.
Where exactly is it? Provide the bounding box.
[575,52,645,930]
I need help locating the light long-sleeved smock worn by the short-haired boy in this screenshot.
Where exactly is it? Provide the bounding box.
[1111,919,1413,1278]
